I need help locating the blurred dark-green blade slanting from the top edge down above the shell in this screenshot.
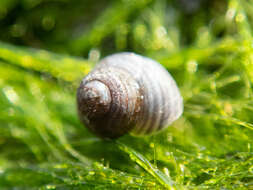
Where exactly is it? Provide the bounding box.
[69,0,152,55]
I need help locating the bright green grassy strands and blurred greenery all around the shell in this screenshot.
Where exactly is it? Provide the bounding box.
[0,0,253,189]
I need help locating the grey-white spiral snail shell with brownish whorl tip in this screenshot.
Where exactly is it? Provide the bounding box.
[77,53,183,138]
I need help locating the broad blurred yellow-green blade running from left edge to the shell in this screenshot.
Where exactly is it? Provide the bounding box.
[0,42,92,82]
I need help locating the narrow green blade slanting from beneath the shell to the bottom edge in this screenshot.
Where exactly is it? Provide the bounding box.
[116,141,178,189]
